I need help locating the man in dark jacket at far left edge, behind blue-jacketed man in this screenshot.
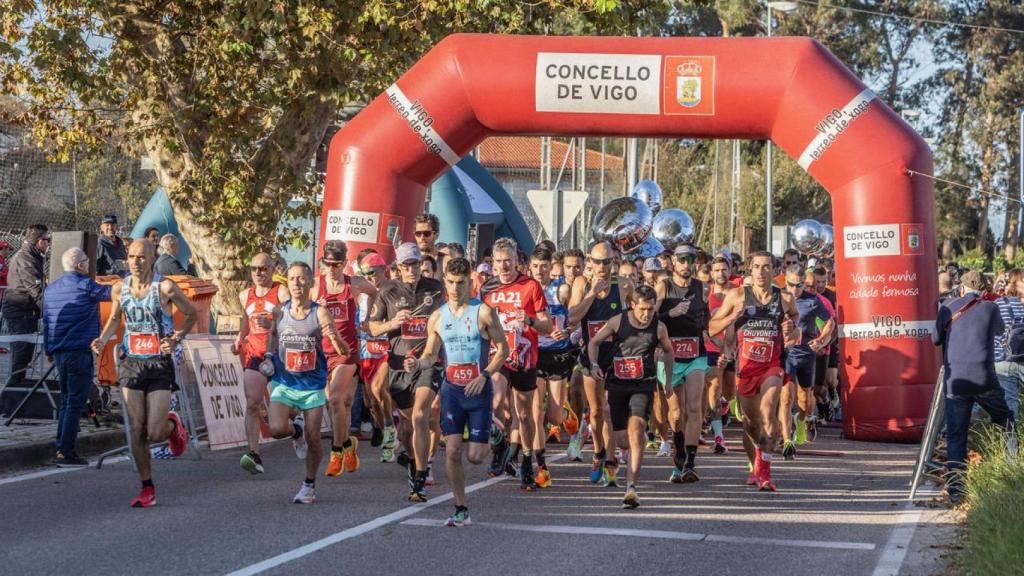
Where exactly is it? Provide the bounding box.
[2,224,50,387]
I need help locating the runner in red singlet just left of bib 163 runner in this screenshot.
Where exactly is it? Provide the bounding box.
[231,252,290,474]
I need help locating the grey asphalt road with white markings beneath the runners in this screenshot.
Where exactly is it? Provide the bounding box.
[0,428,937,576]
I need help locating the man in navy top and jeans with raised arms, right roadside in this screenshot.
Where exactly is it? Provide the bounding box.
[934,271,1012,504]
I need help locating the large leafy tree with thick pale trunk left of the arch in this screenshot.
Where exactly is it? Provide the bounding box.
[0,0,666,311]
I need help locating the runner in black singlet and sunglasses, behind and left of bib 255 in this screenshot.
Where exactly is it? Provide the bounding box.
[569,237,633,486]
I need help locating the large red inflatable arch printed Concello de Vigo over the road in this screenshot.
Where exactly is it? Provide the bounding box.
[319,35,937,441]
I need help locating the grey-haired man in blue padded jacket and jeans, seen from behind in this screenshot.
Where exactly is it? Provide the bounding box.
[43,243,111,467]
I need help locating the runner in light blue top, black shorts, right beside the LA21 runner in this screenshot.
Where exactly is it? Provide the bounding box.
[529,243,577,488]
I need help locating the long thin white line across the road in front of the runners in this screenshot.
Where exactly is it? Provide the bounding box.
[401,518,874,550]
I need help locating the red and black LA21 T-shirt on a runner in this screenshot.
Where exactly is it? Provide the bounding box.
[480,274,548,372]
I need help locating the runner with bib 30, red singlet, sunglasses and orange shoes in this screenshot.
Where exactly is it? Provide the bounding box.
[310,240,377,476]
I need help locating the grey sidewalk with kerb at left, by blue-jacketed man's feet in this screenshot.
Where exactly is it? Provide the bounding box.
[0,418,125,472]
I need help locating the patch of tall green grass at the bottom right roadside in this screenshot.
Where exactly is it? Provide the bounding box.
[958,427,1024,576]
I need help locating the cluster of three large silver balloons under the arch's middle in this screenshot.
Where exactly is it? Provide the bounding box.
[591,180,696,253]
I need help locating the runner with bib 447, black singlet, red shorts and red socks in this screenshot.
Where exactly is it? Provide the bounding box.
[708,251,800,491]
